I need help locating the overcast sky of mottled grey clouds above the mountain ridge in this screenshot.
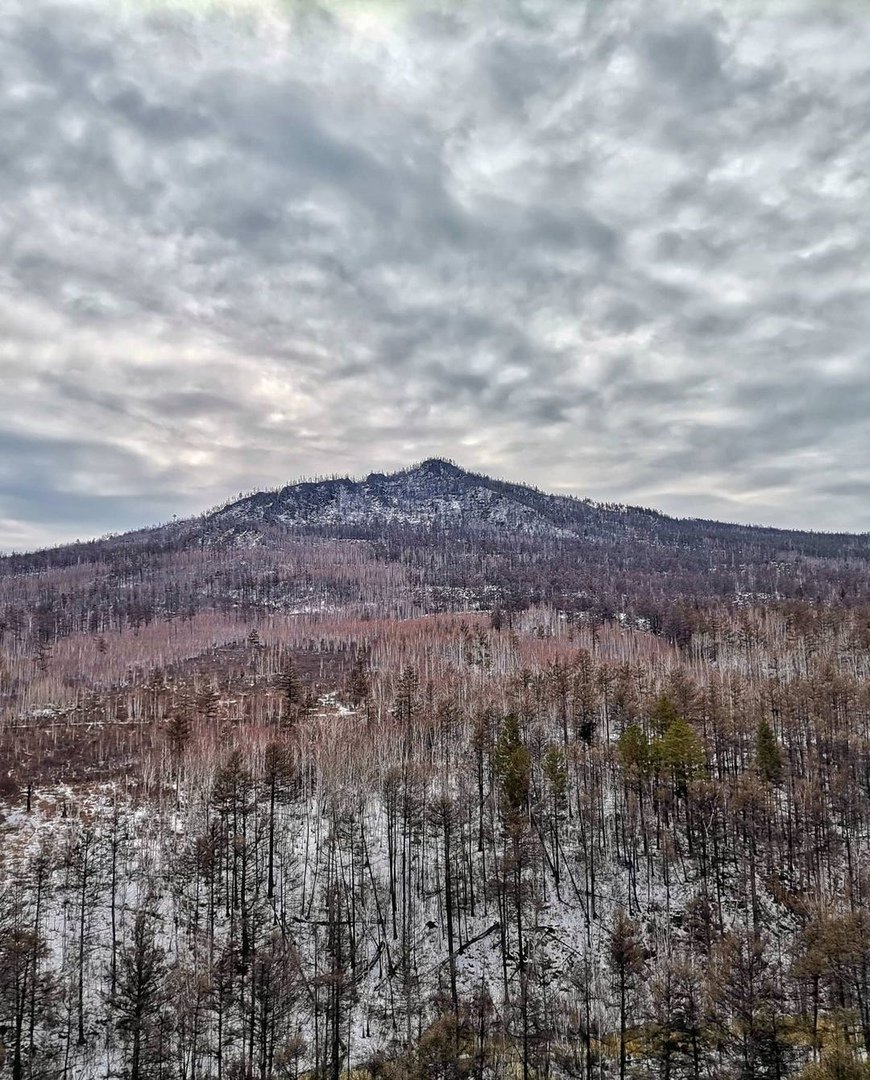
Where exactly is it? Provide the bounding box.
[0,0,870,550]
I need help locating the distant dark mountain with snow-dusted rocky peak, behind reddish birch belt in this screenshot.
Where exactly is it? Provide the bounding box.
[0,459,870,640]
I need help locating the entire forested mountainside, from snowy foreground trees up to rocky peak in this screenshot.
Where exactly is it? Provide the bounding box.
[0,462,870,1080]
